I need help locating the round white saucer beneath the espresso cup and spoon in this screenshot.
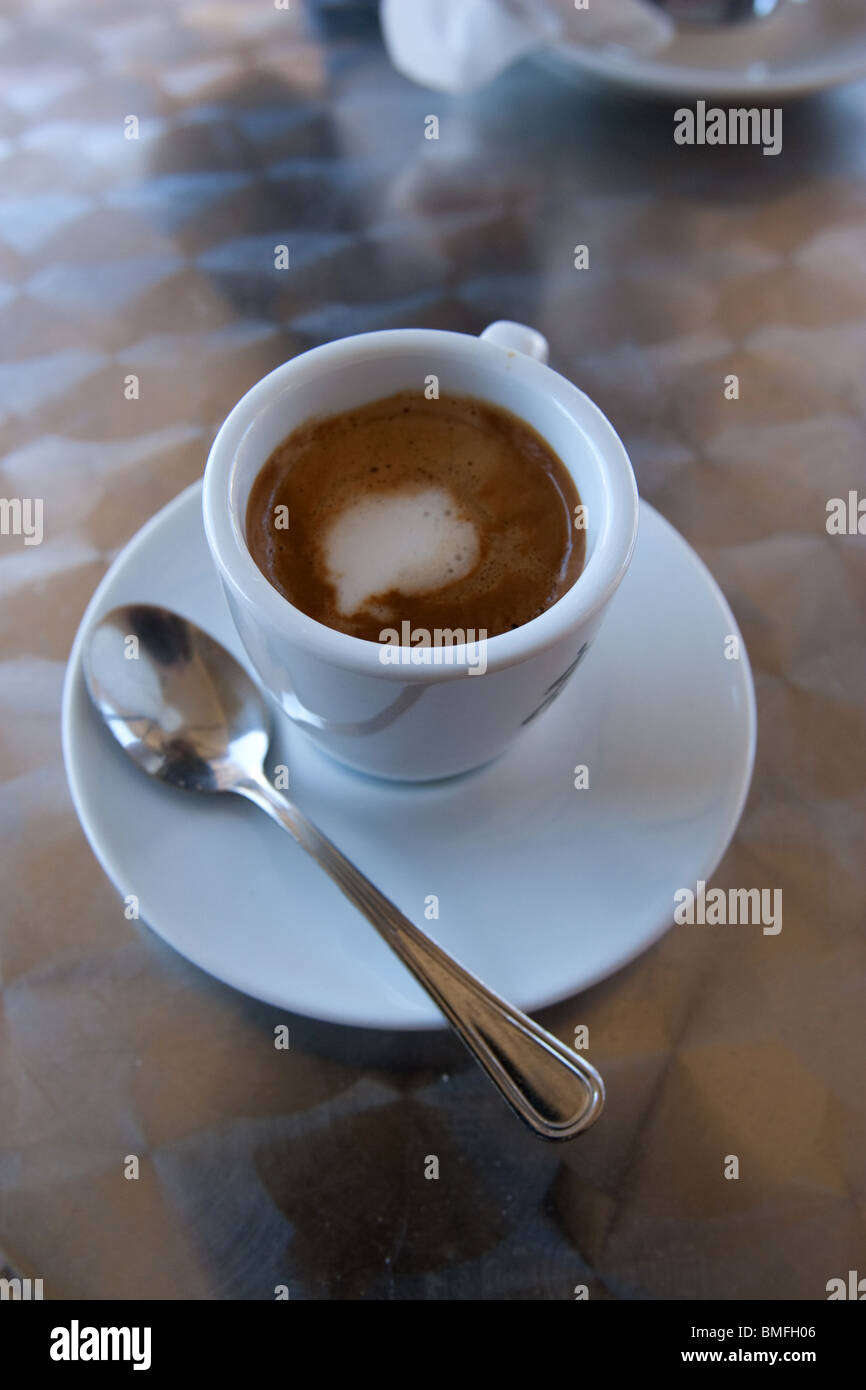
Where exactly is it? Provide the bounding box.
[63,484,755,1029]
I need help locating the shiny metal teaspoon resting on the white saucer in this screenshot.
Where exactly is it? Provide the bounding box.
[83,603,605,1138]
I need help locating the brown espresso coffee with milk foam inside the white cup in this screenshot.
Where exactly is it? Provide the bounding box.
[246,391,585,642]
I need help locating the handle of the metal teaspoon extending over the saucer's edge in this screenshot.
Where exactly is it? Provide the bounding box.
[232,776,605,1140]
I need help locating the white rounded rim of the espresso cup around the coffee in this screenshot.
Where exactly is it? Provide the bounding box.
[202,328,638,672]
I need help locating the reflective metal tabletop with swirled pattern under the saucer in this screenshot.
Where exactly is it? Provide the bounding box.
[0,0,866,1300]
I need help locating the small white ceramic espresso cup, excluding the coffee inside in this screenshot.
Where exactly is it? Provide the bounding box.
[203,322,638,781]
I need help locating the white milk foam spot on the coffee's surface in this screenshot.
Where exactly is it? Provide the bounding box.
[324,488,480,614]
